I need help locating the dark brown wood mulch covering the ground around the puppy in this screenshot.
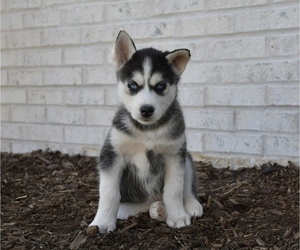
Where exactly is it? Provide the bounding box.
[1,151,300,250]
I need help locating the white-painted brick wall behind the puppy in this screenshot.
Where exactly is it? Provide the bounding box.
[1,0,299,168]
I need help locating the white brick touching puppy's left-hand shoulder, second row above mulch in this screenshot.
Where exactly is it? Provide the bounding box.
[65,126,108,145]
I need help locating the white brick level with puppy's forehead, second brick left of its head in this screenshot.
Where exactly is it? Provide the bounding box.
[44,68,82,85]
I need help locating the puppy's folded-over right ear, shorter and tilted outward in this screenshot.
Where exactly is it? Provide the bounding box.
[166,49,191,75]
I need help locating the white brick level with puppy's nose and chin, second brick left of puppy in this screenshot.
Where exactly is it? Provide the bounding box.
[47,107,84,125]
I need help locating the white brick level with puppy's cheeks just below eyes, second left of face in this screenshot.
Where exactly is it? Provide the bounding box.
[65,88,104,105]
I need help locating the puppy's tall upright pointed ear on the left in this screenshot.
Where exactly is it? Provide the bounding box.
[113,30,136,70]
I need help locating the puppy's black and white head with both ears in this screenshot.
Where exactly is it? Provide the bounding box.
[114,31,190,125]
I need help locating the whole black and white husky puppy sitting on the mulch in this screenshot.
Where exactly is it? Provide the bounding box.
[90,31,203,233]
